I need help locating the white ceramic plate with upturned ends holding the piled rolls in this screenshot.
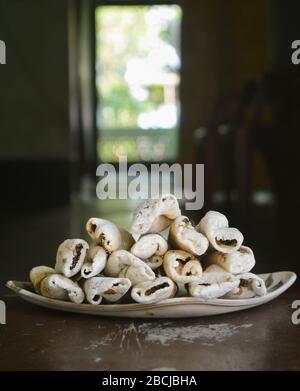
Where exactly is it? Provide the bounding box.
[6,272,296,318]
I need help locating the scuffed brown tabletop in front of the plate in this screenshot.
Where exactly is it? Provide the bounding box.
[0,288,300,370]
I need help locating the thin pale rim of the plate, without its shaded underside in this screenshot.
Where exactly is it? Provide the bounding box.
[6,271,297,313]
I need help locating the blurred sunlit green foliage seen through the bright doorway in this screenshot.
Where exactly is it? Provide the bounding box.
[95,6,181,161]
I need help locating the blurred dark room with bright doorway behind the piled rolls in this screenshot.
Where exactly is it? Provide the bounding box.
[0,0,300,289]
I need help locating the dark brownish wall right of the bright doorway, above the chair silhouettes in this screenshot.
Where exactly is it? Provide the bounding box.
[180,0,272,162]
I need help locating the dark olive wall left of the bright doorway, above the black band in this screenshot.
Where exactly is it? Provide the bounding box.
[0,0,69,159]
